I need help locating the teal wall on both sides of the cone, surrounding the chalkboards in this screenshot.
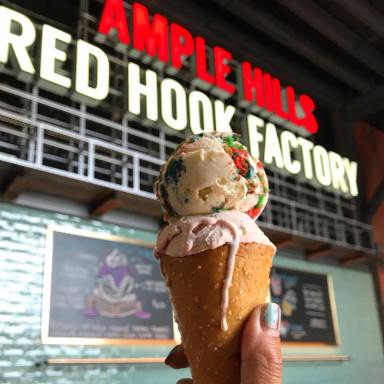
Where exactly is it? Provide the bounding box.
[0,204,384,384]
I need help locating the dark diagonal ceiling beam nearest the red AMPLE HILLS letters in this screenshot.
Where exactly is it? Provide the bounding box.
[213,0,372,92]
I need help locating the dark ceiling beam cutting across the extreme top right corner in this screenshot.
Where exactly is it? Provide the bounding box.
[331,0,384,39]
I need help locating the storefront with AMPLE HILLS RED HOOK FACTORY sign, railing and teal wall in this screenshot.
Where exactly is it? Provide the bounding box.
[0,1,384,383]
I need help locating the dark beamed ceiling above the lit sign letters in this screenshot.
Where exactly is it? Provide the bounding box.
[4,0,384,129]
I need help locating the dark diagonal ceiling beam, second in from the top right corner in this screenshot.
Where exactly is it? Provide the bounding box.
[277,0,384,76]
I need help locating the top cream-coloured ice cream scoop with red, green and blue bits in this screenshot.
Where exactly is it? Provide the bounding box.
[156,133,268,218]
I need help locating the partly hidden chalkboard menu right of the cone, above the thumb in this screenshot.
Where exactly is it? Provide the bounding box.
[271,267,339,345]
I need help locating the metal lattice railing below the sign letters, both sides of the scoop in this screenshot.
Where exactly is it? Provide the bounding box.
[0,77,374,252]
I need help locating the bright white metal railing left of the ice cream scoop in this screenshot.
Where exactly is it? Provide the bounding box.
[0,110,163,199]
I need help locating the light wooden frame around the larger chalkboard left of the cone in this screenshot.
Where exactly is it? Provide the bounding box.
[41,225,180,346]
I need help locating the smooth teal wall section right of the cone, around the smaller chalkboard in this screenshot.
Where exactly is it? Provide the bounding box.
[274,254,384,384]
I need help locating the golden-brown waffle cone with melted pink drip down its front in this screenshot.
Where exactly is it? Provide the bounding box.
[160,243,275,384]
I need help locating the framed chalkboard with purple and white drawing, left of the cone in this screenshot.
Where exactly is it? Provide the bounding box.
[42,227,175,344]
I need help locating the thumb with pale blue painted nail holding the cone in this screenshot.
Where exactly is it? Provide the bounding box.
[241,303,282,384]
